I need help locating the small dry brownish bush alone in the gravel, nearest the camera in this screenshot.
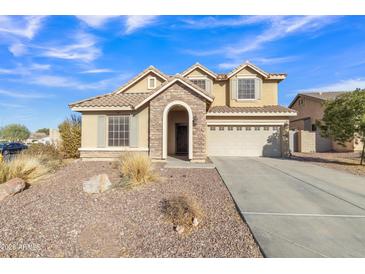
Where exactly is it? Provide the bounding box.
[161,196,202,230]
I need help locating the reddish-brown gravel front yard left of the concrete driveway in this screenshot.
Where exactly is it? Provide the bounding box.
[0,162,262,257]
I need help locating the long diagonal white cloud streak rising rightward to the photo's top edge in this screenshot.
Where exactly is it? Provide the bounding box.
[185,16,337,58]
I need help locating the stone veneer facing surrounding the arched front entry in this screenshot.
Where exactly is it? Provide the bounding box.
[150,83,207,160]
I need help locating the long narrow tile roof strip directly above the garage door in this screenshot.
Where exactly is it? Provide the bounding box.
[208,105,296,114]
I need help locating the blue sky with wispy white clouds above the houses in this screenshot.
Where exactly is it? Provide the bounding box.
[0,16,365,130]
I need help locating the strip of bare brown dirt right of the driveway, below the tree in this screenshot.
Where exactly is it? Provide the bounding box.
[292,152,365,176]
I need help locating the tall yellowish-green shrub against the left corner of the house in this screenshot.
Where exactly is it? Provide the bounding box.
[58,115,81,158]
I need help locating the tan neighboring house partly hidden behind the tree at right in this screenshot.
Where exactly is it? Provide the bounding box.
[289,91,362,152]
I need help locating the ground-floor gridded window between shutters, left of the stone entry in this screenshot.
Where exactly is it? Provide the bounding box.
[108,115,129,147]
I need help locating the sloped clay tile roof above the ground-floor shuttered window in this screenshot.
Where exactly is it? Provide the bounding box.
[70,92,150,108]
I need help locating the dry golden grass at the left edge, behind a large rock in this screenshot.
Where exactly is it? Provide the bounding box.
[0,154,50,183]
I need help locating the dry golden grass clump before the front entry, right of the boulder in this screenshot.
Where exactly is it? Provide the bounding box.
[119,153,158,186]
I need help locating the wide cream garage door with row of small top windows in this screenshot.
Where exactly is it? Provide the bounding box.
[207,125,281,157]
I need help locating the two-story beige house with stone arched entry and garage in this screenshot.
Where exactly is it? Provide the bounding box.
[70,62,296,161]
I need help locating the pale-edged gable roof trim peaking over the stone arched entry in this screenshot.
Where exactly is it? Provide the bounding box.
[135,74,214,109]
